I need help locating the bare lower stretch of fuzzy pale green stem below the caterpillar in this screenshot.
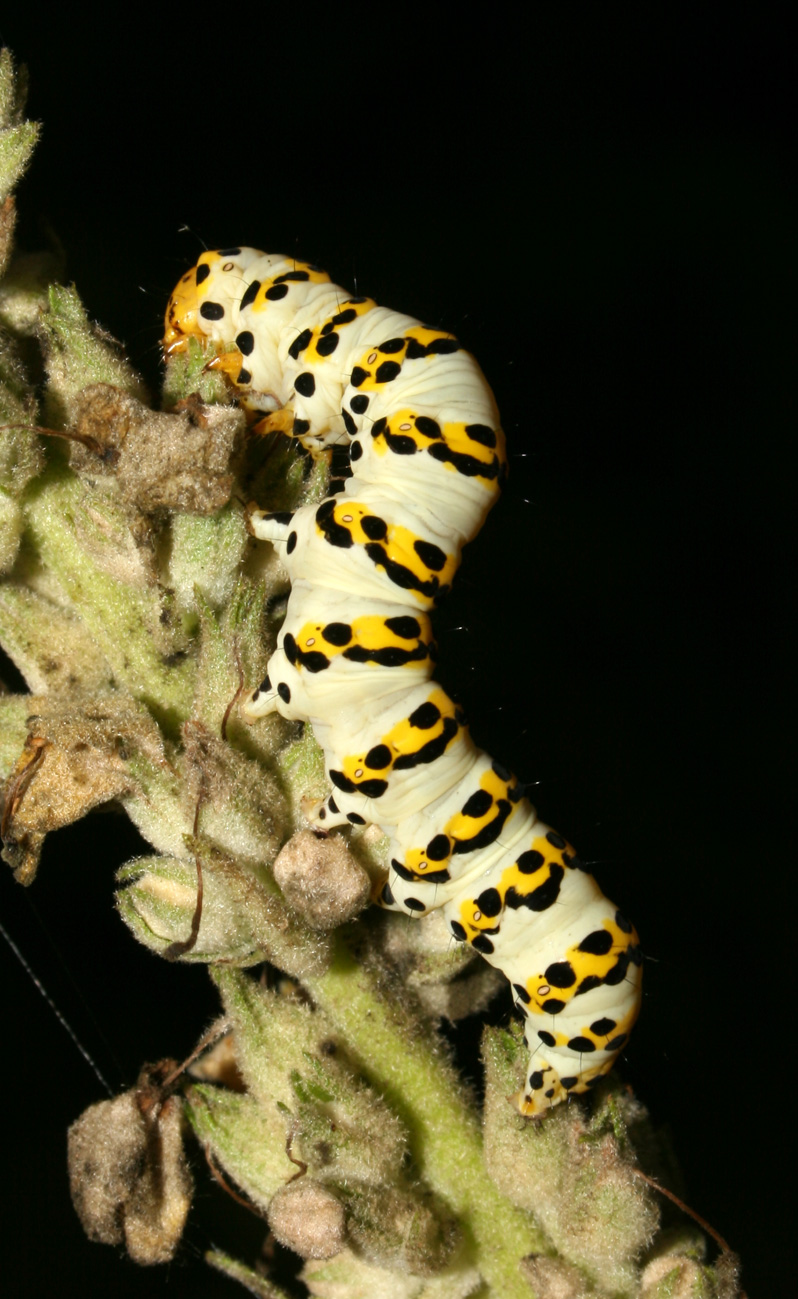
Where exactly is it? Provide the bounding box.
[303,935,547,1299]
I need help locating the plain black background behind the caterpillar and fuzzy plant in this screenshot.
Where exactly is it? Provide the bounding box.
[0,6,797,1299]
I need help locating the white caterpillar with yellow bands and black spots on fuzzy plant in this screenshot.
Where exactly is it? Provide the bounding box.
[164,248,642,1116]
